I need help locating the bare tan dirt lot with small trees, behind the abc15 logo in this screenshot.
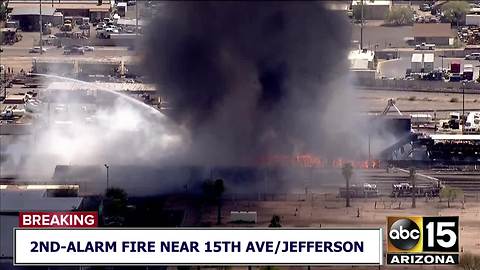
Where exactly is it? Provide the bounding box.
[186,194,474,269]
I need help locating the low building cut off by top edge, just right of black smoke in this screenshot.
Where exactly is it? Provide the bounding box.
[352,0,392,20]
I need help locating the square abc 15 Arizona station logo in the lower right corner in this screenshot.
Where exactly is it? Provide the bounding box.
[387,217,459,264]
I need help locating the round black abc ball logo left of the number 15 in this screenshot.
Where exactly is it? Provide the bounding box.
[388,218,421,250]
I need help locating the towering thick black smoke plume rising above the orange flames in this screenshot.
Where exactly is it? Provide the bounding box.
[145,1,356,164]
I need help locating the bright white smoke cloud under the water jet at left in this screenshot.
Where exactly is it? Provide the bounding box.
[0,83,188,178]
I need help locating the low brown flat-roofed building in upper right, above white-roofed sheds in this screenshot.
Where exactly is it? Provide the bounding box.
[413,23,455,46]
